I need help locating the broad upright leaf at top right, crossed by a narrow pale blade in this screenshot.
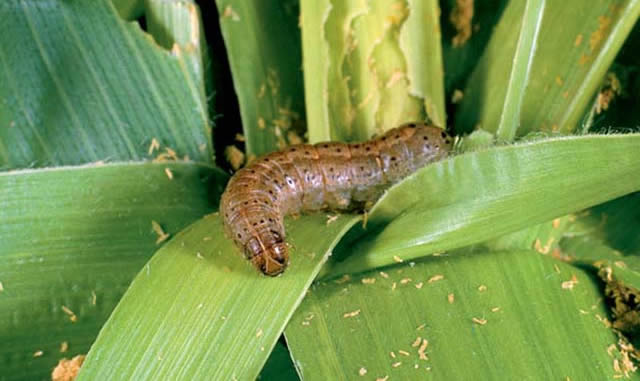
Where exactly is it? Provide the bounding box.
[456,0,640,136]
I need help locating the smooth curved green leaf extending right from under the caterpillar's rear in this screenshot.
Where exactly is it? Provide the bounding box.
[333,134,640,275]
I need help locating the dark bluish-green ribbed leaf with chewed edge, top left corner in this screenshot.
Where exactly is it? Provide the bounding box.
[0,0,212,168]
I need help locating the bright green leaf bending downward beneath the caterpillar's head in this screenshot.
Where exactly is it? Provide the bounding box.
[78,213,359,380]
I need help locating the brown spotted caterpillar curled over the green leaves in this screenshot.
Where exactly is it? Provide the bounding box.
[220,123,452,276]
